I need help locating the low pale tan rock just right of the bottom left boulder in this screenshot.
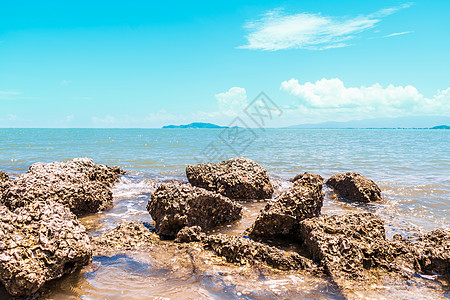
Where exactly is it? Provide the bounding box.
[92,221,159,255]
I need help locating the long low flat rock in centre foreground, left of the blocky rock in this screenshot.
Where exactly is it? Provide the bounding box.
[203,234,314,270]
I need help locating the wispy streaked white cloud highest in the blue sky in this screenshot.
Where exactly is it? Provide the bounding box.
[239,4,411,51]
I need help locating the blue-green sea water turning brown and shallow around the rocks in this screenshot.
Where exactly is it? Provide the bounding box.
[0,129,450,299]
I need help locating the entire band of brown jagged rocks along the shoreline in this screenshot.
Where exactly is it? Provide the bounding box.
[0,158,450,297]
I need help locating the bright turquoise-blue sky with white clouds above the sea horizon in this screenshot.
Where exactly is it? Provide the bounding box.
[0,0,450,127]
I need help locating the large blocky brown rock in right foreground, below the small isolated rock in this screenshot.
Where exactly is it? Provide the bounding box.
[298,213,393,282]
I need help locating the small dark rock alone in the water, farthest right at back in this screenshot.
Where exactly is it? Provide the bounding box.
[326,172,382,202]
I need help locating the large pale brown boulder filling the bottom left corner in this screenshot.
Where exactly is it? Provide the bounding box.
[0,201,92,296]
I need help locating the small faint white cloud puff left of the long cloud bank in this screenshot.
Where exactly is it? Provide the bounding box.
[215,87,247,116]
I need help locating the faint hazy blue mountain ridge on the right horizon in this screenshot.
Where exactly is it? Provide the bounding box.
[285,116,450,129]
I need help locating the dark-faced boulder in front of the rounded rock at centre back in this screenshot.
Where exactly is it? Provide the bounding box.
[147,183,242,238]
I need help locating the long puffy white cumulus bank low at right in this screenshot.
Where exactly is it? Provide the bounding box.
[280,78,450,116]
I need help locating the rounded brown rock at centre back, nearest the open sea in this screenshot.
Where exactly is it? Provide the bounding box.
[186,157,273,200]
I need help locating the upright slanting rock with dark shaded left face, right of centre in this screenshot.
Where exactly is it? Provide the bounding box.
[247,174,324,238]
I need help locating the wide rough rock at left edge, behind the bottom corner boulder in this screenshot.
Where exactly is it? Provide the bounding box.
[0,158,123,215]
